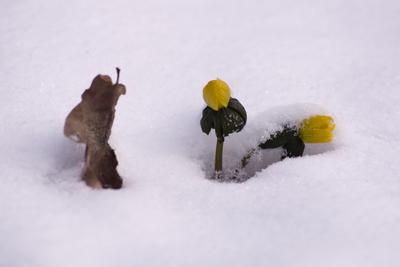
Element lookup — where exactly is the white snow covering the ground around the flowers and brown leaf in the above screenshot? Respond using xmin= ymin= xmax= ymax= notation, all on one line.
xmin=0 ymin=0 xmax=400 ymax=267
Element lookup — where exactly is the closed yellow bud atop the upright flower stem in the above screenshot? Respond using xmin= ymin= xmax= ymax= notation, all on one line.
xmin=203 ymin=79 xmax=231 ymax=111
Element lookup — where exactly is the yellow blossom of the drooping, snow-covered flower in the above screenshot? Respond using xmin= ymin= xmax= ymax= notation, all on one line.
xmin=300 ymin=115 xmax=335 ymax=143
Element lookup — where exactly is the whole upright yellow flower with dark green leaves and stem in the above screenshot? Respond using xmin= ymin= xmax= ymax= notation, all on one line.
xmin=200 ymin=79 xmax=247 ymax=178
